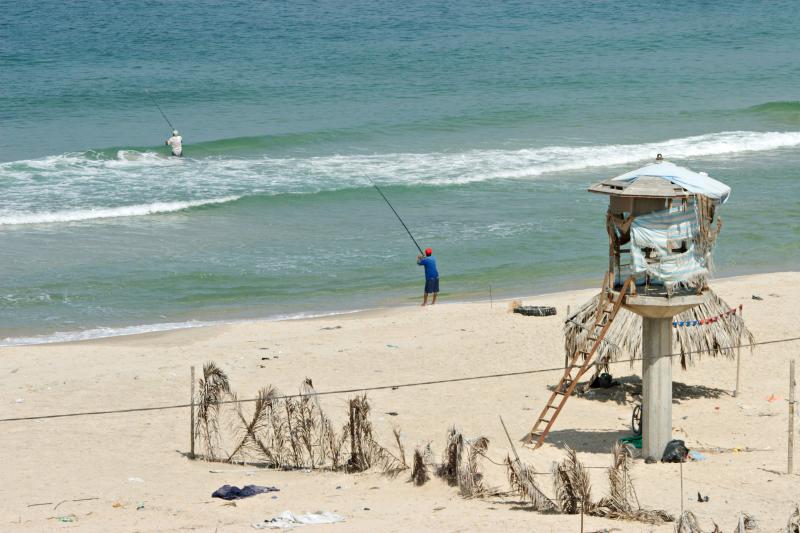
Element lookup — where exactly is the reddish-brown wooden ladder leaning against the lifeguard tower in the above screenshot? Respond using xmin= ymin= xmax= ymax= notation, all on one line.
xmin=523 ymin=274 xmax=633 ymax=449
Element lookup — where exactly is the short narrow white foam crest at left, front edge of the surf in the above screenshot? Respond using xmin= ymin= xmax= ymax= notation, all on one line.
xmin=0 ymin=196 xmax=240 ymax=226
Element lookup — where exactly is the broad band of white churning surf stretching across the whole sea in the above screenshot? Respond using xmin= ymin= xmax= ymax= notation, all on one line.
xmin=0 ymin=131 xmax=800 ymax=225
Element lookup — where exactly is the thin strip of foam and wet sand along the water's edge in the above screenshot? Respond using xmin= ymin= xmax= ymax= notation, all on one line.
xmin=0 ymin=270 xmax=797 ymax=349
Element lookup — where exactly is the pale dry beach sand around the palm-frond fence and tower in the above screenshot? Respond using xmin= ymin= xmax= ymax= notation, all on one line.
xmin=0 ymin=273 xmax=800 ymax=533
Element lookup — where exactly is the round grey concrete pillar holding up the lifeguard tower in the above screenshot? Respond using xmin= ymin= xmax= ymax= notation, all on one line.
xmin=642 ymin=317 xmax=672 ymax=460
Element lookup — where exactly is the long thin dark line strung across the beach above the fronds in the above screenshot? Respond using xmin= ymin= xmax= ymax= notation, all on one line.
xmin=0 ymin=336 xmax=800 ymax=423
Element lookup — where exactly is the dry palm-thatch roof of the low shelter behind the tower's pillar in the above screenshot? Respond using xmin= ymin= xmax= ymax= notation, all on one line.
xmin=564 ymin=289 xmax=754 ymax=369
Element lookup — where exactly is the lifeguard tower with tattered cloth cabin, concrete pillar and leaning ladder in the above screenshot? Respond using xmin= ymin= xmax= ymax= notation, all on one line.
xmin=525 ymin=154 xmax=730 ymax=459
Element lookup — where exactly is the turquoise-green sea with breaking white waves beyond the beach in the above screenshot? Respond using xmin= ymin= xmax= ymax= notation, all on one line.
xmin=0 ymin=0 xmax=800 ymax=345
